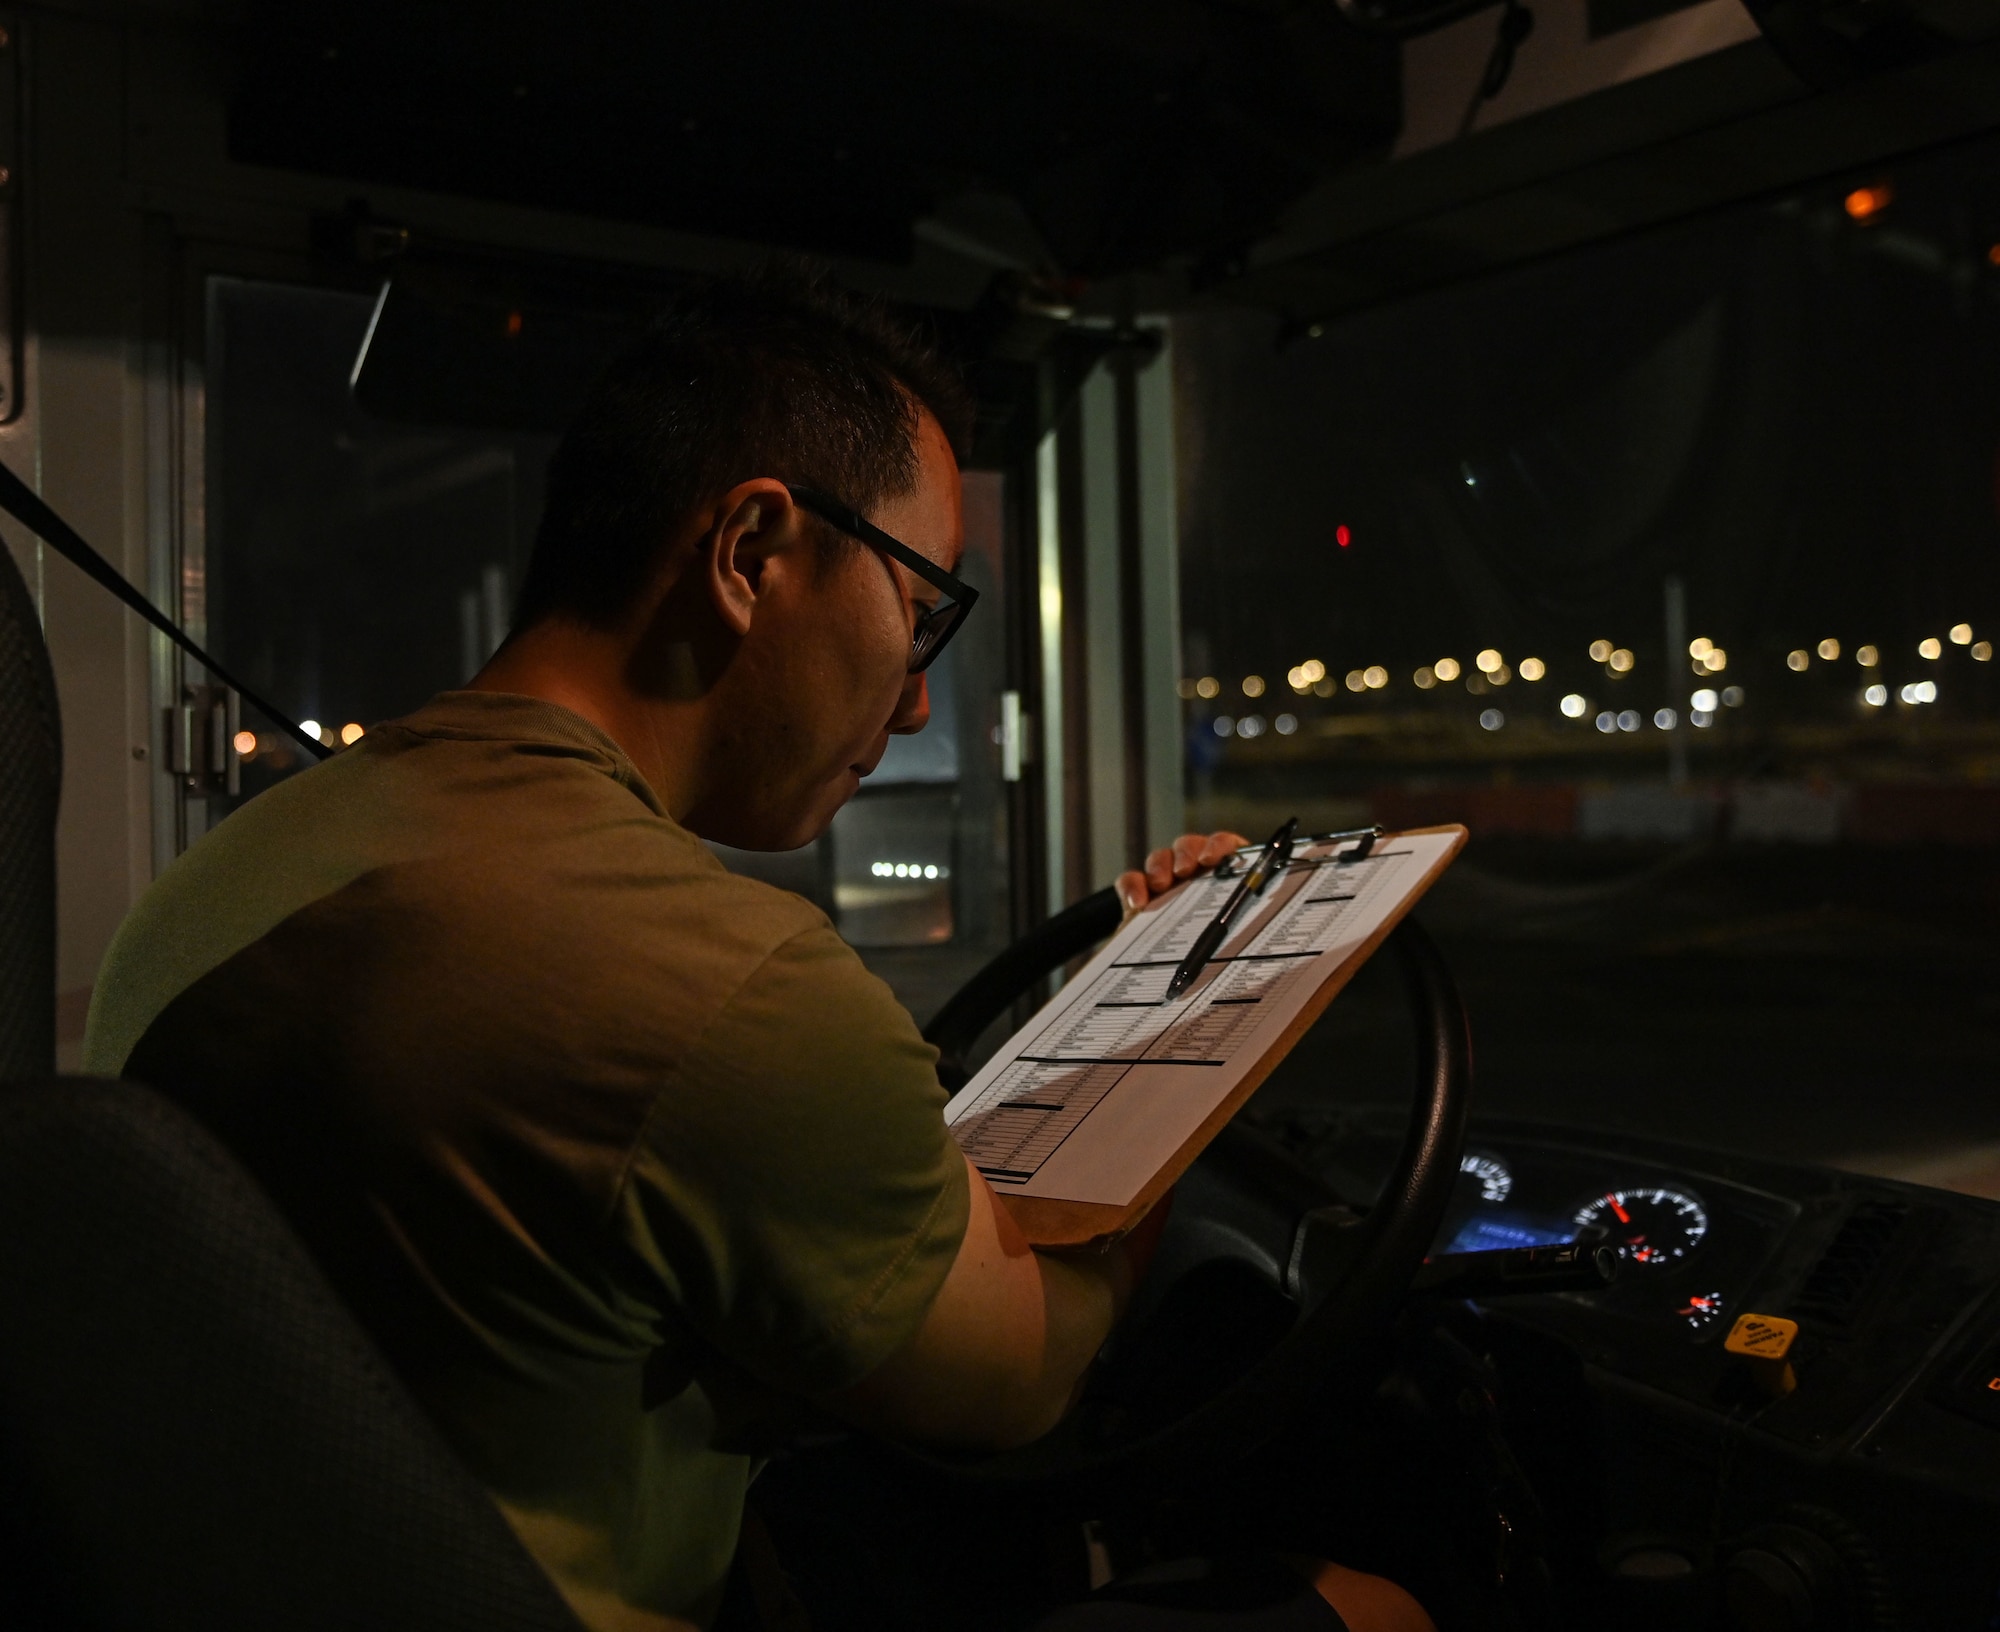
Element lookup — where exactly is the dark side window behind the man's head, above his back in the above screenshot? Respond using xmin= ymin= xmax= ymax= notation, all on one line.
xmin=205 ymin=278 xmax=554 ymax=816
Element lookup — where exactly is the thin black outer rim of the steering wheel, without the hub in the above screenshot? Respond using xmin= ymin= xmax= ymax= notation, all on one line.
xmin=918 ymin=890 xmax=1472 ymax=1500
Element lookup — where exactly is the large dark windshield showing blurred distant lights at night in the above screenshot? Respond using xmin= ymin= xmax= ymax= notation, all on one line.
xmin=1176 ymin=131 xmax=2000 ymax=1194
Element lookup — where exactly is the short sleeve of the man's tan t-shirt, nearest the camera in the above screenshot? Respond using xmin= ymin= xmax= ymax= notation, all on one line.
xmin=618 ymin=922 xmax=968 ymax=1394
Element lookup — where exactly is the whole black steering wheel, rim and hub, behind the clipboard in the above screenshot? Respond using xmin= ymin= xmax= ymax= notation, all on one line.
xmin=918 ymin=890 xmax=1472 ymax=1502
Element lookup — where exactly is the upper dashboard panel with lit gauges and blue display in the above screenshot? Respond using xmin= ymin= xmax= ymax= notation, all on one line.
xmin=1438 ymin=1124 xmax=2000 ymax=1500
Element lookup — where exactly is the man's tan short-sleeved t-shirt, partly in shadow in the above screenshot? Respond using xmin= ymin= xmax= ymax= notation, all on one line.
xmin=86 ymin=692 xmax=968 ymax=1632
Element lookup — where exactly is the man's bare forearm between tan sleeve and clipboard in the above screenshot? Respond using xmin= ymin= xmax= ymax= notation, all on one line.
xmin=826 ymin=1162 xmax=1166 ymax=1450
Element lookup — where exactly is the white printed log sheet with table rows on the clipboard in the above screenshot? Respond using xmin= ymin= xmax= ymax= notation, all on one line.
xmin=944 ymin=828 xmax=1464 ymax=1206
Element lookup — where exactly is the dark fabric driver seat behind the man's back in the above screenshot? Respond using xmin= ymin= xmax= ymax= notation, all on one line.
xmin=0 ymin=544 xmax=582 ymax=1632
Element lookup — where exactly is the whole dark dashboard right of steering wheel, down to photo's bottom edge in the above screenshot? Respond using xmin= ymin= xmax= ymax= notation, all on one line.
xmin=1284 ymin=1112 xmax=2000 ymax=1628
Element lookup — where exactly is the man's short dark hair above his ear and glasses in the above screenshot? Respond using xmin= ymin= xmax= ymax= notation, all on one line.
xmin=514 ymin=264 xmax=972 ymax=628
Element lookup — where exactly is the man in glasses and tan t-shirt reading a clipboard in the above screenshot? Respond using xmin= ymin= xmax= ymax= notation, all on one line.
xmin=86 ymin=274 xmax=1432 ymax=1632
